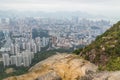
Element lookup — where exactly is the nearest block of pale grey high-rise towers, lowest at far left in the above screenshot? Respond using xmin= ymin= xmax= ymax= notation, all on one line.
xmin=2 ymin=50 xmax=34 ymax=67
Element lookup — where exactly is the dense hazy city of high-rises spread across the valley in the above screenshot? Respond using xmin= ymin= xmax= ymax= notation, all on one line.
xmin=0 ymin=17 xmax=111 ymax=67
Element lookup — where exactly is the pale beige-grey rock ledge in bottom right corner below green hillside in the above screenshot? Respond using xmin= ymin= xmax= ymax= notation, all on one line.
xmin=79 ymin=71 xmax=120 ymax=80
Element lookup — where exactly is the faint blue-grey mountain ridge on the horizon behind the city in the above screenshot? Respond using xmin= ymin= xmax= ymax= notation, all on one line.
xmin=0 ymin=10 xmax=105 ymax=19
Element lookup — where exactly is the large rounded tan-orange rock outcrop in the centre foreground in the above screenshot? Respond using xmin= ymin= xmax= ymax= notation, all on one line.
xmin=4 ymin=54 xmax=97 ymax=80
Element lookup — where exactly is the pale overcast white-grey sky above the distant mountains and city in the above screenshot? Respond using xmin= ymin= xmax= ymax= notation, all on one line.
xmin=0 ymin=0 xmax=120 ymax=16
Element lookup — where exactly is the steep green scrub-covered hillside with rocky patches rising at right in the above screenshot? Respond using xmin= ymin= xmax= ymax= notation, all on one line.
xmin=74 ymin=21 xmax=120 ymax=71
